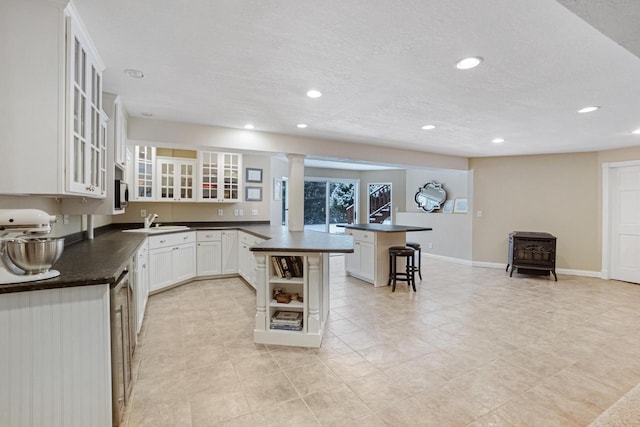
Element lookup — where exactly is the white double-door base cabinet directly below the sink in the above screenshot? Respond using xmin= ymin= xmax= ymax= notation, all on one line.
xmin=148 ymin=231 xmax=196 ymax=292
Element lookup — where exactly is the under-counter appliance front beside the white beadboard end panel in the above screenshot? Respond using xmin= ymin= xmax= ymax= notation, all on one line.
xmin=110 ymin=268 xmax=135 ymax=426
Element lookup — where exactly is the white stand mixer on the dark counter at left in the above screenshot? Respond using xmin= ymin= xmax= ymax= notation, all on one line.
xmin=0 ymin=209 xmax=64 ymax=284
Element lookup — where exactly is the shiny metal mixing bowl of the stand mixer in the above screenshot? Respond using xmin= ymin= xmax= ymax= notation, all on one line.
xmin=5 ymin=237 xmax=64 ymax=274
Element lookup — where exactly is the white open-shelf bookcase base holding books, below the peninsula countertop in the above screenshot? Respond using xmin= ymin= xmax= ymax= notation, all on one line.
xmin=254 ymin=252 xmax=329 ymax=348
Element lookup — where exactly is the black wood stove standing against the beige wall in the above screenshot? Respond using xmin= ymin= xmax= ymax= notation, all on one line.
xmin=506 ymin=231 xmax=558 ymax=282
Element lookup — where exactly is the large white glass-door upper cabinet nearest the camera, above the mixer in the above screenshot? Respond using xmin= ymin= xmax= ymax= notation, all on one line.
xmin=0 ymin=0 xmax=108 ymax=197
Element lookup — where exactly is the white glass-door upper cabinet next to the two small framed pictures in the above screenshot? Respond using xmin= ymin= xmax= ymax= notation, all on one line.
xmin=198 ymin=151 xmax=242 ymax=203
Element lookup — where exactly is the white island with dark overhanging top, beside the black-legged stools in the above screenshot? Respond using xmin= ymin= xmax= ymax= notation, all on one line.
xmin=341 ymin=224 xmax=432 ymax=287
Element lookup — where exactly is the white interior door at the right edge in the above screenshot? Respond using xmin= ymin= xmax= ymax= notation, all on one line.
xmin=611 ymin=166 xmax=640 ymax=283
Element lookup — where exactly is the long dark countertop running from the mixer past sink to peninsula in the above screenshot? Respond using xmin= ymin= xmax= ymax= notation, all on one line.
xmin=0 ymin=223 xmax=353 ymax=293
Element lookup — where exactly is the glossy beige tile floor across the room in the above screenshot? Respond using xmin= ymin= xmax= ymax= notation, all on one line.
xmin=125 ymin=256 xmax=640 ymax=427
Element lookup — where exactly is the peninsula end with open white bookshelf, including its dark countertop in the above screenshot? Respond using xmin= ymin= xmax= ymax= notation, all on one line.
xmin=251 ymin=231 xmax=353 ymax=348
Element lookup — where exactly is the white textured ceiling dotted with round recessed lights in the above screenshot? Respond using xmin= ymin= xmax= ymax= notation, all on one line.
xmin=74 ymin=0 xmax=640 ymax=157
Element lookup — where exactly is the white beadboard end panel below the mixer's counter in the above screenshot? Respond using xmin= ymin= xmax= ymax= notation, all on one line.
xmin=0 ymin=285 xmax=111 ymax=427
